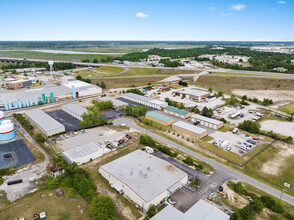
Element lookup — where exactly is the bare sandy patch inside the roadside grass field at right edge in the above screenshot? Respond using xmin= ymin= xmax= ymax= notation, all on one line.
xmin=260 ymin=143 xmax=294 ymax=176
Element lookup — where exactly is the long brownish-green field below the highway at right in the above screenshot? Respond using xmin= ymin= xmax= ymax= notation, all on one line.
xmin=196 ymin=75 xmax=294 ymax=93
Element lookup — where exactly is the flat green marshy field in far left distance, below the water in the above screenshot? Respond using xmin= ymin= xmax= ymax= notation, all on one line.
xmin=0 ymin=51 xmax=106 ymax=61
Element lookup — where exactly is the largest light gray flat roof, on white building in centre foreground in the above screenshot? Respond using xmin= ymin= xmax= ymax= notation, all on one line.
xmin=100 ymin=150 xmax=187 ymax=202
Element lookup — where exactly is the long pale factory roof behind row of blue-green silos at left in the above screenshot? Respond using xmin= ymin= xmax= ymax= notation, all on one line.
xmin=0 ymin=86 xmax=72 ymax=104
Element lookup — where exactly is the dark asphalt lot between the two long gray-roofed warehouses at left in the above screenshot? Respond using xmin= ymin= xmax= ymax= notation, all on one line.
xmin=47 ymin=110 xmax=82 ymax=131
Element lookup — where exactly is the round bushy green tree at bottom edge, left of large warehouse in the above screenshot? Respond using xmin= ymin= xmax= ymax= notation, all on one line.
xmin=89 ymin=195 xmax=115 ymax=220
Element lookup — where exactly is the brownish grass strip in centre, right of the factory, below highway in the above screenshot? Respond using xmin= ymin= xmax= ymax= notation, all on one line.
xmin=92 ymin=76 xmax=165 ymax=89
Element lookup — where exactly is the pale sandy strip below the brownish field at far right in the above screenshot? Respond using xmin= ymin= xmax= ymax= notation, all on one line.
xmin=232 ymin=89 xmax=294 ymax=102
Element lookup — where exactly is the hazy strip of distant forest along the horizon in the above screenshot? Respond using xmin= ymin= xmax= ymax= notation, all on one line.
xmin=0 ymin=41 xmax=293 ymax=49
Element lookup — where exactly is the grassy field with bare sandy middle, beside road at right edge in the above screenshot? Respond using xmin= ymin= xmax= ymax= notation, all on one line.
xmin=243 ymin=142 xmax=294 ymax=196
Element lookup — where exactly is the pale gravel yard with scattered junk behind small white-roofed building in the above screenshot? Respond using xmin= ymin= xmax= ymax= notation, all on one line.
xmin=57 ymin=127 xmax=126 ymax=151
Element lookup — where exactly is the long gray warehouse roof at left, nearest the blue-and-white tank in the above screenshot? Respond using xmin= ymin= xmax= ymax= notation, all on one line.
xmin=25 ymin=109 xmax=65 ymax=132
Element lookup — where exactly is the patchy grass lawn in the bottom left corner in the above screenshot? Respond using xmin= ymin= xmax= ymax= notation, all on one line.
xmin=0 ymin=187 xmax=91 ymax=220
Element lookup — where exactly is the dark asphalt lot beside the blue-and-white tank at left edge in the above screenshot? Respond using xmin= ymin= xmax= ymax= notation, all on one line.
xmin=0 ymin=140 xmax=35 ymax=169
